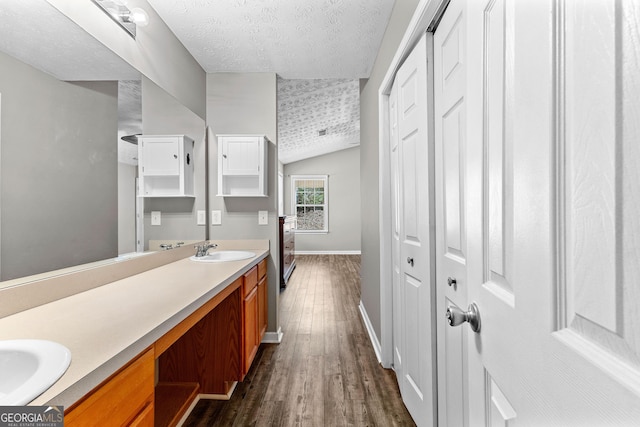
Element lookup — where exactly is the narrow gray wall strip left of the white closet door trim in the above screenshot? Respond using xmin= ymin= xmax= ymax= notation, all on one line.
xmin=360 ymin=0 xmax=418 ymax=340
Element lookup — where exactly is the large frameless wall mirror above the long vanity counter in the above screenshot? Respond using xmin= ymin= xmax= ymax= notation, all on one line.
xmin=0 ymin=1 xmax=206 ymax=287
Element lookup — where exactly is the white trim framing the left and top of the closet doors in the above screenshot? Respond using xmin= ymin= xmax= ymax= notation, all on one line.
xmin=378 ymin=0 xmax=449 ymax=368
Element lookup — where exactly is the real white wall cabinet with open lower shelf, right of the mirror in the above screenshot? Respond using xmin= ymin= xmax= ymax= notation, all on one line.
xmin=218 ymin=135 xmax=269 ymax=197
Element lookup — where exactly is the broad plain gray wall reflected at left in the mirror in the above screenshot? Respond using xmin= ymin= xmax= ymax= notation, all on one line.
xmin=0 ymin=53 xmax=118 ymax=280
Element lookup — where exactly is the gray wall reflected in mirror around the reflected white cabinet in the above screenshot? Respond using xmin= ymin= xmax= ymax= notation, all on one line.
xmin=142 ymin=76 xmax=206 ymax=250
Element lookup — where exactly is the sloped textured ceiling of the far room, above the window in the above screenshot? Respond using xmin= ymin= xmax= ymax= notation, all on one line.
xmin=278 ymin=79 xmax=360 ymax=163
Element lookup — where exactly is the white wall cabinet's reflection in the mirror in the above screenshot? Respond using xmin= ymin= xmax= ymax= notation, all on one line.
xmin=138 ymin=135 xmax=194 ymax=197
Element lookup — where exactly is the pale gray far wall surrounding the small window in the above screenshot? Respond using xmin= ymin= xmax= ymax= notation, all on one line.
xmin=284 ymin=147 xmax=360 ymax=253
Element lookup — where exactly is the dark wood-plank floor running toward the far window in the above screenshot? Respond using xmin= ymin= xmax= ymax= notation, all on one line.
xmin=184 ymin=255 xmax=415 ymax=427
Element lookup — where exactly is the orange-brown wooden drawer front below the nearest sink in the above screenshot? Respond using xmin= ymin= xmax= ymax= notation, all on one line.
xmin=64 ymin=349 xmax=154 ymax=426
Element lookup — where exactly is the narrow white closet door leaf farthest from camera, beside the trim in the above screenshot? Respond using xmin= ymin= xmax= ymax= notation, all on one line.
xmin=392 ymin=32 xmax=436 ymax=425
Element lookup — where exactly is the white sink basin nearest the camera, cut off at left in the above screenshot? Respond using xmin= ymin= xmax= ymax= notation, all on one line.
xmin=0 ymin=340 xmax=71 ymax=406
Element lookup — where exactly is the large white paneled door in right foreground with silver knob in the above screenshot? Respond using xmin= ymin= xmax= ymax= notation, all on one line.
xmin=460 ymin=0 xmax=640 ymax=426
